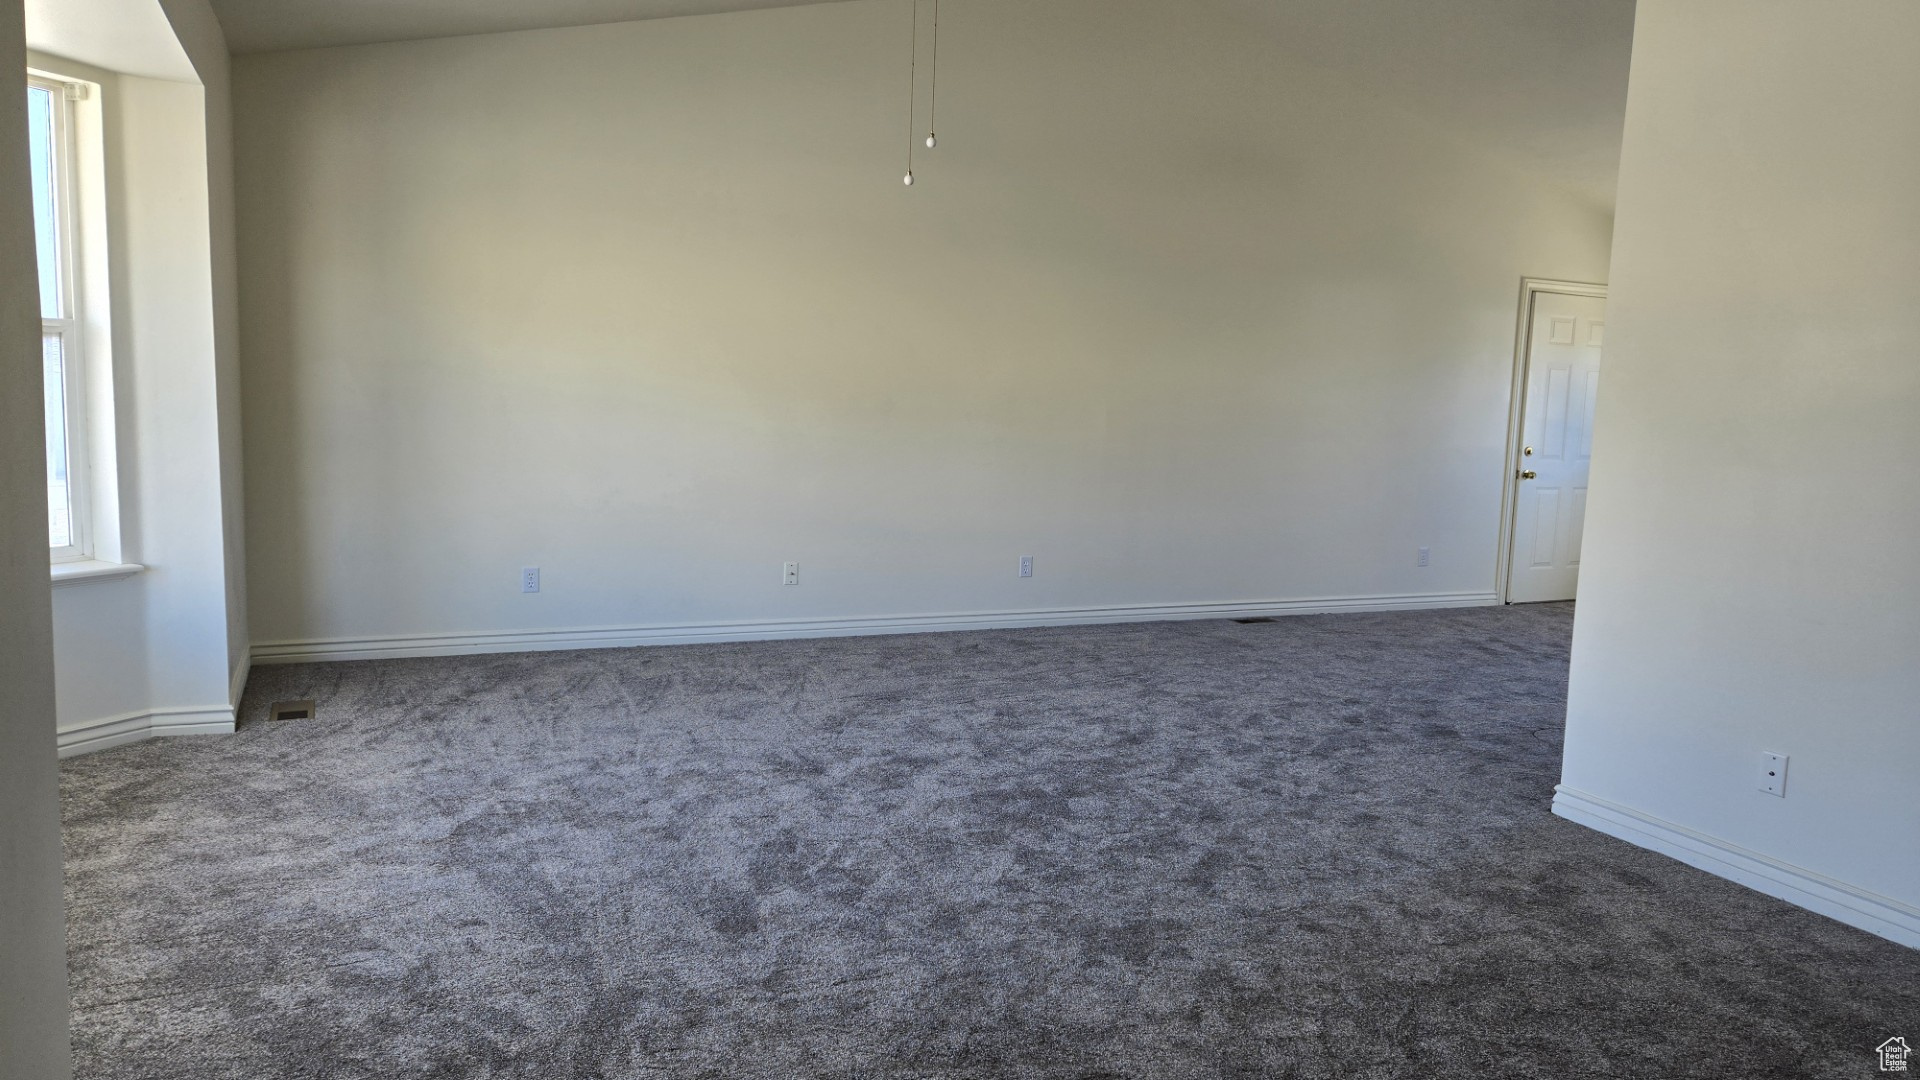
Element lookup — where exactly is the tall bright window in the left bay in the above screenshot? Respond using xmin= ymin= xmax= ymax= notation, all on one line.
xmin=27 ymin=75 xmax=94 ymax=563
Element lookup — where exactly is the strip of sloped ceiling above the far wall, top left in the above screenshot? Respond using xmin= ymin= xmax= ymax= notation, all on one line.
xmin=204 ymin=0 xmax=856 ymax=52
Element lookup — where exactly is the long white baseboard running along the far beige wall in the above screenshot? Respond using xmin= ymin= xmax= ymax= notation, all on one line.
xmin=253 ymin=592 xmax=1496 ymax=663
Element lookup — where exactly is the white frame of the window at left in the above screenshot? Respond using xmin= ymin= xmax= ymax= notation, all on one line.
xmin=27 ymin=73 xmax=94 ymax=563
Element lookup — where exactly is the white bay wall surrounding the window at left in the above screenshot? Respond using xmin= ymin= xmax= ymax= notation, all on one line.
xmin=29 ymin=0 xmax=246 ymax=751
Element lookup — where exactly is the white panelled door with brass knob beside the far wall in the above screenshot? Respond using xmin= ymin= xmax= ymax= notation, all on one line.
xmin=1507 ymin=292 xmax=1607 ymax=603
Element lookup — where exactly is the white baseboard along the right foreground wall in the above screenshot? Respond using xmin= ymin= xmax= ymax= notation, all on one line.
xmin=1553 ymin=784 xmax=1920 ymax=949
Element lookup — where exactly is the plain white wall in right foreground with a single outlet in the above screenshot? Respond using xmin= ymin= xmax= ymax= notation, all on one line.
xmin=1557 ymin=0 xmax=1920 ymax=945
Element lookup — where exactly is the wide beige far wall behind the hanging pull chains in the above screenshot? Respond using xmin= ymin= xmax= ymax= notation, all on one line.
xmin=234 ymin=0 xmax=1630 ymax=642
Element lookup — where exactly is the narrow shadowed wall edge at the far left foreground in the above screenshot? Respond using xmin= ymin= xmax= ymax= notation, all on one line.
xmin=0 ymin=0 xmax=71 ymax=1080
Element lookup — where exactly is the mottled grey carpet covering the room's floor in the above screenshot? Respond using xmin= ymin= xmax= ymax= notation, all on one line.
xmin=63 ymin=605 xmax=1920 ymax=1080
